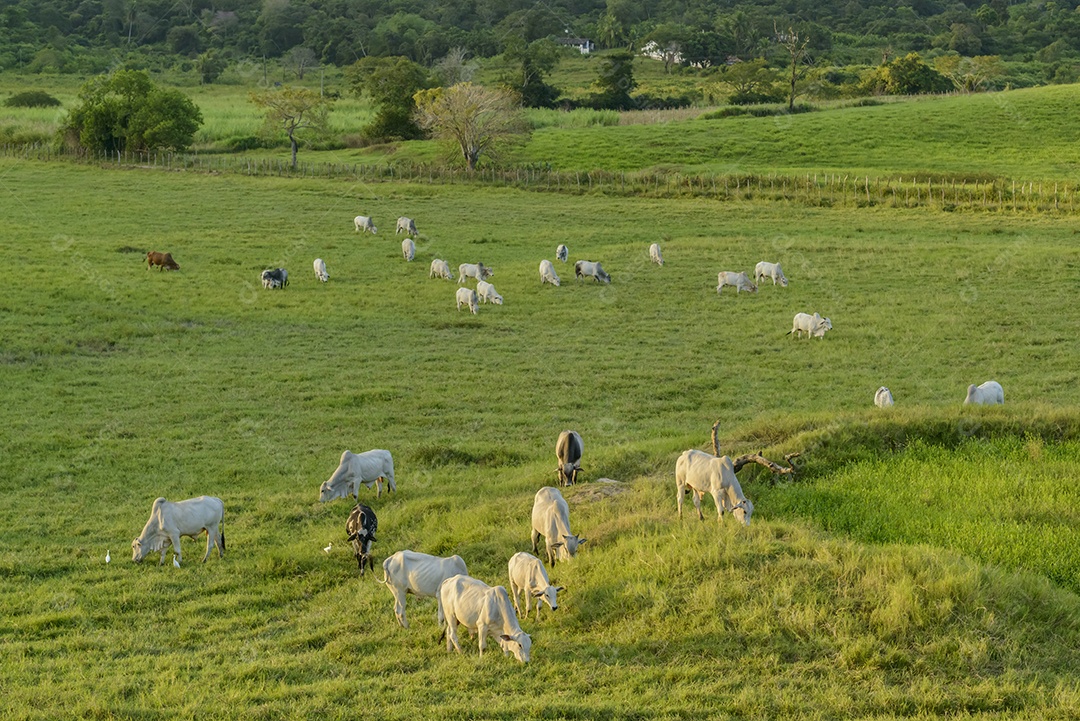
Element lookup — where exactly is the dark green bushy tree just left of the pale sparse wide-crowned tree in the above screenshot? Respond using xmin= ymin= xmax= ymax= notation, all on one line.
xmin=346 ymin=57 xmax=428 ymax=140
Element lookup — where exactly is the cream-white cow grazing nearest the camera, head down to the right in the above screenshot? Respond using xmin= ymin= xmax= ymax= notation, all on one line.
xmin=438 ymin=574 xmax=532 ymax=664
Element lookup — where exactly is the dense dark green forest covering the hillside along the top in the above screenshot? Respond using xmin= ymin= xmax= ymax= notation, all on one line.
xmin=6 ymin=0 xmax=1080 ymax=82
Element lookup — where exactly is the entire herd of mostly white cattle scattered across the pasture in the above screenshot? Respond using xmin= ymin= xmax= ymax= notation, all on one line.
xmin=132 ymin=211 xmax=1004 ymax=663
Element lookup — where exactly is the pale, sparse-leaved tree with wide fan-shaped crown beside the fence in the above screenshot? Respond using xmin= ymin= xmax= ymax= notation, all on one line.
xmin=416 ymin=83 xmax=528 ymax=171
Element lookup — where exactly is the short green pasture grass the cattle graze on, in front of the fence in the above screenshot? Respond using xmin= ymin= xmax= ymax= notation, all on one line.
xmin=0 ymin=161 xmax=1080 ymax=719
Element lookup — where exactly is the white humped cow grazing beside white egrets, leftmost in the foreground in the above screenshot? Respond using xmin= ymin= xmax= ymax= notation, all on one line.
xmin=132 ymin=495 xmax=225 ymax=566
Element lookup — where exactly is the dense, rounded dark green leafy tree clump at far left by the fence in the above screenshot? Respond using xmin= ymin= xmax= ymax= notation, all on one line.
xmin=60 ymin=70 xmax=203 ymax=153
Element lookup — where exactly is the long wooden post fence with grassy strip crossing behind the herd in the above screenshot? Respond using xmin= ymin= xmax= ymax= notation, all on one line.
xmin=6 ymin=145 xmax=1078 ymax=214
